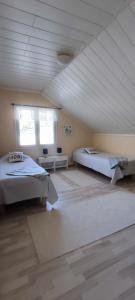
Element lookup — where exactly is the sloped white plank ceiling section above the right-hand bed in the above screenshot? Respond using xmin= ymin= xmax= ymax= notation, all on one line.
xmin=44 ymin=0 xmax=135 ymax=134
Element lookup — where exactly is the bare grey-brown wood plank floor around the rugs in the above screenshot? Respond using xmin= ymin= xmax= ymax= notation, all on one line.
xmin=0 ymin=166 xmax=135 ymax=300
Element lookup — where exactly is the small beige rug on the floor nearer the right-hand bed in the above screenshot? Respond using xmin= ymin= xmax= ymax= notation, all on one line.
xmin=62 ymin=170 xmax=100 ymax=187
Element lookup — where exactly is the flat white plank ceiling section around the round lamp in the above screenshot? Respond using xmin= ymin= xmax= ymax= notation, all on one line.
xmin=0 ymin=0 xmax=134 ymax=91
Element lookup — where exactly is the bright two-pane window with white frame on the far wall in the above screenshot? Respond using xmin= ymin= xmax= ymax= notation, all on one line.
xmin=16 ymin=106 xmax=55 ymax=146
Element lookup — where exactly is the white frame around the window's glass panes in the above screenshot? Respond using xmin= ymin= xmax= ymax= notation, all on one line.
xmin=15 ymin=105 xmax=57 ymax=148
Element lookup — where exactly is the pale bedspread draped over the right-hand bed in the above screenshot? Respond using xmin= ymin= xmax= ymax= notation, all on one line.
xmin=73 ymin=149 xmax=135 ymax=183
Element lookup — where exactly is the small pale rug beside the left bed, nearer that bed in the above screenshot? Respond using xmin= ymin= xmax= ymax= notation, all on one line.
xmin=51 ymin=174 xmax=72 ymax=193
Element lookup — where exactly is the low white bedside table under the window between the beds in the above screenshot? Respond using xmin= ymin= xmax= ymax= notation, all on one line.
xmin=38 ymin=155 xmax=68 ymax=172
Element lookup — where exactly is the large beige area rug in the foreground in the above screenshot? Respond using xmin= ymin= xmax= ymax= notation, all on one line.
xmin=28 ymin=191 xmax=135 ymax=262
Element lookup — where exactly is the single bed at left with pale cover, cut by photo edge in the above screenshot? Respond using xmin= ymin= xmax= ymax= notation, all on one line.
xmin=0 ymin=155 xmax=58 ymax=204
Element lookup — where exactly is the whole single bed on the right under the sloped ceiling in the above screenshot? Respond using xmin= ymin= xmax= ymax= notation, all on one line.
xmin=73 ymin=148 xmax=135 ymax=184
